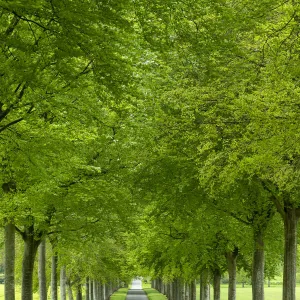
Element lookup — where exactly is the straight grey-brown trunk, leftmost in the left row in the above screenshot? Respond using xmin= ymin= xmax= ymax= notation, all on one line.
xmin=4 ymin=223 xmax=15 ymax=300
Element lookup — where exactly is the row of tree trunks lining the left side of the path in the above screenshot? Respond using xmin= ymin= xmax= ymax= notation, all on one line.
xmin=5 ymin=231 xmax=120 ymax=300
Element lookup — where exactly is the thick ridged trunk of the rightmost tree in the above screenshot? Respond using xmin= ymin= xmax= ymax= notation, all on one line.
xmin=283 ymin=207 xmax=298 ymax=300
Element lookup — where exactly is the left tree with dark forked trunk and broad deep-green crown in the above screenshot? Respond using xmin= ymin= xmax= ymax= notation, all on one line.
xmin=0 ymin=1 xmax=143 ymax=299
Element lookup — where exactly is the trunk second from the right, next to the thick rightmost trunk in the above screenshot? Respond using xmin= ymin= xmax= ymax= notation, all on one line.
xmin=252 ymin=230 xmax=265 ymax=300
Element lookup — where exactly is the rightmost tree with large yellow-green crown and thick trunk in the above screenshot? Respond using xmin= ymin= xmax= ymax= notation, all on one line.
xmin=133 ymin=1 xmax=298 ymax=299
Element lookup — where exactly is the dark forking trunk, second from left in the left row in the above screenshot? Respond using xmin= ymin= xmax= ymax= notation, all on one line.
xmin=22 ymin=225 xmax=41 ymax=300
